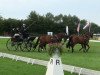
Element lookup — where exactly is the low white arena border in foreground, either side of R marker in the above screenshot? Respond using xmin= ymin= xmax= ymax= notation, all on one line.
xmin=0 ymin=52 xmax=100 ymax=75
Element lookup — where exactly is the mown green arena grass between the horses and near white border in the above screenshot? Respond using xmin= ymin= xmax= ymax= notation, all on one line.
xmin=0 ymin=39 xmax=100 ymax=71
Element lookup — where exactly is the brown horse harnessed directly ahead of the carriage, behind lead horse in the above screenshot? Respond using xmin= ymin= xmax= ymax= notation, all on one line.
xmin=34 ymin=33 xmax=68 ymax=50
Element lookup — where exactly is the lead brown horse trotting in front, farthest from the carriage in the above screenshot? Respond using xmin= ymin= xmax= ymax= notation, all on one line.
xmin=66 ymin=33 xmax=93 ymax=52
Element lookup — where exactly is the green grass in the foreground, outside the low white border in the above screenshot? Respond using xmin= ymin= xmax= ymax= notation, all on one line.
xmin=0 ymin=58 xmax=76 ymax=75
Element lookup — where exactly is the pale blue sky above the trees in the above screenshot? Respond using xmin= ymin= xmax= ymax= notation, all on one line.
xmin=0 ymin=0 xmax=100 ymax=26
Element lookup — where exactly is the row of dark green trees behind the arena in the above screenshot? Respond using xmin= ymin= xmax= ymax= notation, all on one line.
xmin=0 ymin=11 xmax=100 ymax=35
